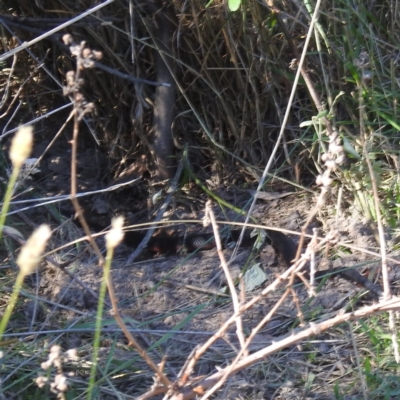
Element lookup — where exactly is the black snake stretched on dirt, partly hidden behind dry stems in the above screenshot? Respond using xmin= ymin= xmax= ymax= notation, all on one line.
xmin=125 ymin=229 xmax=383 ymax=298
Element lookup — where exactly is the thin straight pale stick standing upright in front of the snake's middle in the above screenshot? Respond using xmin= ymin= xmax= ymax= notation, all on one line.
xmin=204 ymin=200 xmax=246 ymax=349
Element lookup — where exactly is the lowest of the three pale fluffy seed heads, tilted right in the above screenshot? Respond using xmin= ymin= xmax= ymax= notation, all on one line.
xmin=17 ymin=225 xmax=51 ymax=276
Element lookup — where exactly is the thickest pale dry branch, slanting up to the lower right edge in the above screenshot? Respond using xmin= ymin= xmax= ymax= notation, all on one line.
xmin=171 ymin=297 xmax=400 ymax=400
